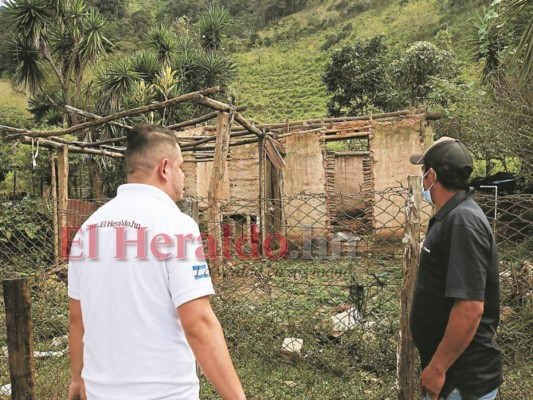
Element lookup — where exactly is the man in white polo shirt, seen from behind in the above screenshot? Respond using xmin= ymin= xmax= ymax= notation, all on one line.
xmin=68 ymin=125 xmax=245 ymax=400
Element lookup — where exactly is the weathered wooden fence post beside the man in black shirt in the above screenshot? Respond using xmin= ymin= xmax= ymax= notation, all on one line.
xmin=396 ymin=176 xmax=421 ymax=400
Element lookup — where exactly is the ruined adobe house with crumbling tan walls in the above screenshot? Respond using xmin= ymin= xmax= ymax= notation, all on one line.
xmin=184 ymin=111 xmax=433 ymax=241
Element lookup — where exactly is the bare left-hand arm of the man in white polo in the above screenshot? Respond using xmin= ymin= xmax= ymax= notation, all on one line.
xmin=68 ymin=299 xmax=86 ymax=400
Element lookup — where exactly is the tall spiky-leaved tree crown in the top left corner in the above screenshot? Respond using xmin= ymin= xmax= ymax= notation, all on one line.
xmin=6 ymin=0 xmax=107 ymax=123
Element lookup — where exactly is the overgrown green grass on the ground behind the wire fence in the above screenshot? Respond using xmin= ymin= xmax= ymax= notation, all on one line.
xmin=0 ymin=243 xmax=533 ymax=400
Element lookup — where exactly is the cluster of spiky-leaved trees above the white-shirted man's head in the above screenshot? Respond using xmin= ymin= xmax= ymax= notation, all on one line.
xmin=95 ymin=6 xmax=236 ymax=119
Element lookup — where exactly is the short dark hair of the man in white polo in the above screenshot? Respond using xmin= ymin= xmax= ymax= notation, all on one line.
xmin=124 ymin=125 xmax=178 ymax=175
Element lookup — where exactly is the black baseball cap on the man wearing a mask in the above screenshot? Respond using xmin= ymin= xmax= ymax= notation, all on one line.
xmin=409 ymin=136 xmax=474 ymax=172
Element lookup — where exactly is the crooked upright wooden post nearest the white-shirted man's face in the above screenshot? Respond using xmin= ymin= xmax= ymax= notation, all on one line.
xmin=207 ymin=112 xmax=231 ymax=279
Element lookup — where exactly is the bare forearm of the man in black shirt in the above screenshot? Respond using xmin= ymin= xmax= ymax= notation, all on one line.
xmin=420 ymin=300 xmax=483 ymax=400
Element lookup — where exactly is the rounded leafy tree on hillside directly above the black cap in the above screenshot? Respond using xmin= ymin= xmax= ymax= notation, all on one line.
xmin=392 ymin=42 xmax=456 ymax=106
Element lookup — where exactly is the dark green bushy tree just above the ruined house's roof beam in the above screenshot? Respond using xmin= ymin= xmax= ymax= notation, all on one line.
xmin=322 ymin=36 xmax=398 ymax=116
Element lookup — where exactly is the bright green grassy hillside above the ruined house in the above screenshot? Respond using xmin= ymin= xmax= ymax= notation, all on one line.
xmin=233 ymin=0 xmax=479 ymax=122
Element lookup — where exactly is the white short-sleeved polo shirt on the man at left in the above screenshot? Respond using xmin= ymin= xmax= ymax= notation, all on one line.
xmin=68 ymin=184 xmax=214 ymax=400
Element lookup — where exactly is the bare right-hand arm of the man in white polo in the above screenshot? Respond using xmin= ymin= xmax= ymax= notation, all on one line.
xmin=178 ymin=297 xmax=246 ymax=400
